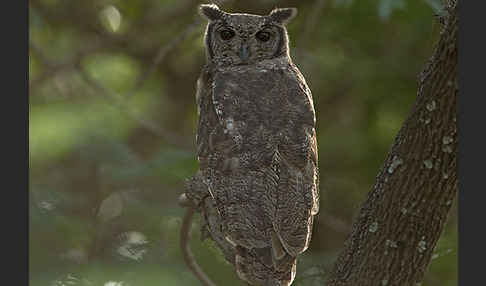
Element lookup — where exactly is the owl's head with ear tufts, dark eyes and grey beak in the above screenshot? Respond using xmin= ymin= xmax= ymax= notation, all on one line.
xmin=199 ymin=4 xmax=297 ymax=66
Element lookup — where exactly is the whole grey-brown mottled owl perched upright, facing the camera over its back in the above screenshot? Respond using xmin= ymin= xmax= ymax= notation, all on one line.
xmin=188 ymin=4 xmax=319 ymax=286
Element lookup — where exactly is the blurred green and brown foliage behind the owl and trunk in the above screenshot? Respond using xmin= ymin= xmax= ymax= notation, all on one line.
xmin=29 ymin=0 xmax=457 ymax=286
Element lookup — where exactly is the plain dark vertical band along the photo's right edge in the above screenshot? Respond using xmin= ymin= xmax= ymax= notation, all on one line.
xmin=457 ymin=0 xmax=474 ymax=285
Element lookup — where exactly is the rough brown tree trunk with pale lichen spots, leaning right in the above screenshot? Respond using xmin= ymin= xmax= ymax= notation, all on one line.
xmin=327 ymin=1 xmax=458 ymax=286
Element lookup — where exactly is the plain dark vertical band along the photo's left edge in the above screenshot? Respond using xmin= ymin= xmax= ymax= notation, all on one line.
xmin=12 ymin=1 xmax=29 ymax=285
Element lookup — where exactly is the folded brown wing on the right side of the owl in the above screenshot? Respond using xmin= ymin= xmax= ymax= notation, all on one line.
xmin=273 ymin=66 xmax=319 ymax=256
